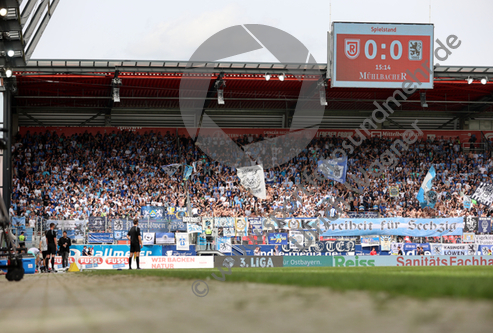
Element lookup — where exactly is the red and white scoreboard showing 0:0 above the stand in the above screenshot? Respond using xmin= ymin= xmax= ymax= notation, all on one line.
xmin=327 ymin=22 xmax=433 ymax=89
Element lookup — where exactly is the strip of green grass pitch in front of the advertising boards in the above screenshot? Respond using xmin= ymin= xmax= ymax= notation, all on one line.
xmin=83 ymin=266 xmax=493 ymax=300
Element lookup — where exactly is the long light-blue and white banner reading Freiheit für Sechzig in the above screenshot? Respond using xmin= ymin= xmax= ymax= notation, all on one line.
xmin=320 ymin=217 xmax=464 ymax=237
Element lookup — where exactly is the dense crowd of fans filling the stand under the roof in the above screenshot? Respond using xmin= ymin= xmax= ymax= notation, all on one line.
xmin=10 ymin=131 xmax=493 ymax=219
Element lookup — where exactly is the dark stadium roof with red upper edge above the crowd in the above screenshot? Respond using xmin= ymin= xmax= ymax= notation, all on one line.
xmin=9 ymin=60 xmax=493 ymax=129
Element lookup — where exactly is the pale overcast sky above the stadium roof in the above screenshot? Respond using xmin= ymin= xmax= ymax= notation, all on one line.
xmin=31 ymin=0 xmax=493 ymax=66
